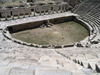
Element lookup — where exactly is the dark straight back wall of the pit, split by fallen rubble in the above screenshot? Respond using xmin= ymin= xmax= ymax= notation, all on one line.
xmin=8 ymin=16 xmax=73 ymax=33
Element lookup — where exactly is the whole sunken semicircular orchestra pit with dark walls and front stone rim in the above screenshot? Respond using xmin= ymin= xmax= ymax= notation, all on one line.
xmin=4 ymin=16 xmax=90 ymax=48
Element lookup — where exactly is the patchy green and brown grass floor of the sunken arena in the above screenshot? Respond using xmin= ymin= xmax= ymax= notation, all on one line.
xmin=11 ymin=21 xmax=89 ymax=45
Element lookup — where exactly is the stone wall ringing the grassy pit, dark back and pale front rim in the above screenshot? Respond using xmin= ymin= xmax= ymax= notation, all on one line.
xmin=3 ymin=16 xmax=91 ymax=48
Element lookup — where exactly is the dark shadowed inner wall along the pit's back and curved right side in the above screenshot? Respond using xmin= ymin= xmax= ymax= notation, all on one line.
xmin=8 ymin=16 xmax=91 ymax=33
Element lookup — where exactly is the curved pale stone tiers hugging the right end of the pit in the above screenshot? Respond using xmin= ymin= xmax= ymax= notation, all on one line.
xmin=77 ymin=17 xmax=99 ymax=47
